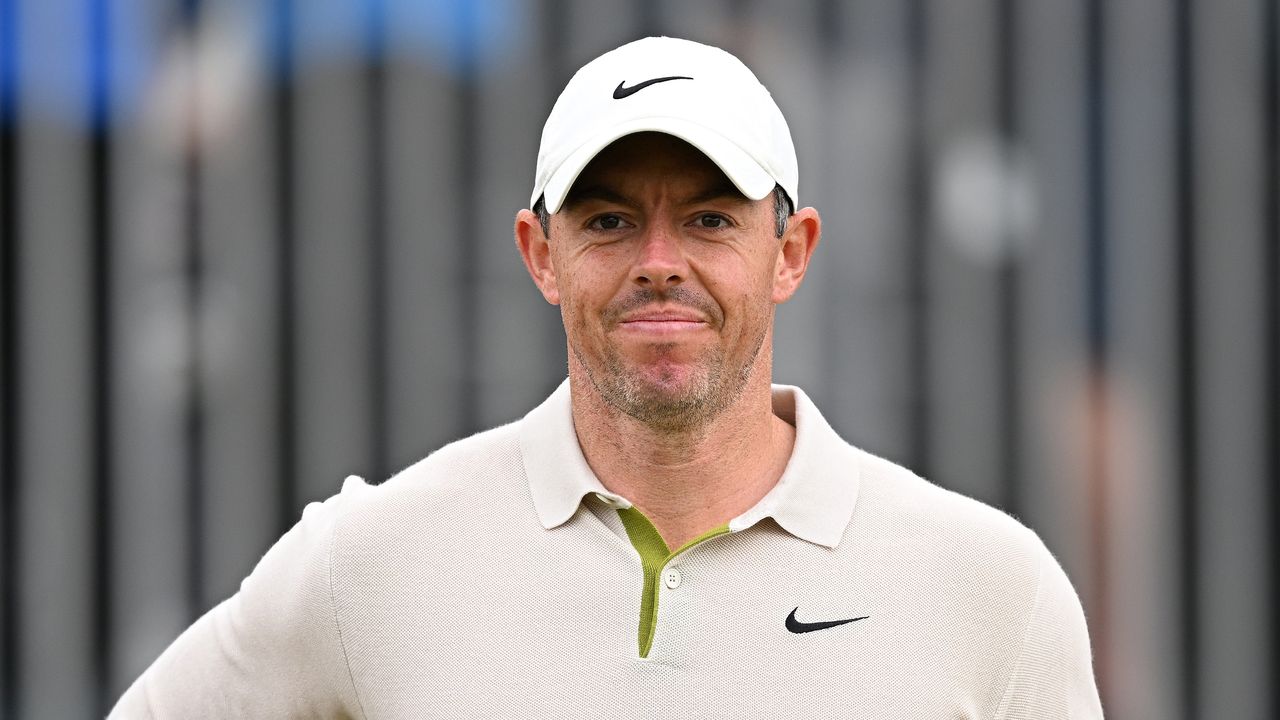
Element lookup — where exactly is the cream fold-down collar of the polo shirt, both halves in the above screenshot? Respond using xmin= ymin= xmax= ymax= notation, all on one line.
xmin=520 ymin=379 xmax=860 ymax=547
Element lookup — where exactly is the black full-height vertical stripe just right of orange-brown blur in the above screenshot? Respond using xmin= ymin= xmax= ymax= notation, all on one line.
xmin=1172 ymin=0 xmax=1201 ymax=719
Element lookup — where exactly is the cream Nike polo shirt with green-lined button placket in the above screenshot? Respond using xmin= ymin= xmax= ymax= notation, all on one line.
xmin=111 ymin=383 xmax=1102 ymax=720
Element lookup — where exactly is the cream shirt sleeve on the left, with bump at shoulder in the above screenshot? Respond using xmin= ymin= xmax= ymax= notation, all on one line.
xmin=109 ymin=478 xmax=365 ymax=720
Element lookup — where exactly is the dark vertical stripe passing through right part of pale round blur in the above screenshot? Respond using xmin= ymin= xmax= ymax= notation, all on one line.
xmin=996 ymin=0 xmax=1023 ymax=515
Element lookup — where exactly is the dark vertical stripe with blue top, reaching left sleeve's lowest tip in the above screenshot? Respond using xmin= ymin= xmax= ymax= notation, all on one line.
xmin=88 ymin=0 xmax=114 ymax=715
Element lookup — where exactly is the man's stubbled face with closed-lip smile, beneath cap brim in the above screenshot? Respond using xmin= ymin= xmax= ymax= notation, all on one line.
xmin=535 ymin=133 xmax=790 ymax=429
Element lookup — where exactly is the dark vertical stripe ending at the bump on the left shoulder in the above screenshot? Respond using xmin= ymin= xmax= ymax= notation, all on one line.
xmin=365 ymin=0 xmax=390 ymax=482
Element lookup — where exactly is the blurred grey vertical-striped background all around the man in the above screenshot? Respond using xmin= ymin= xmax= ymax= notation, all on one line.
xmin=0 ymin=0 xmax=1280 ymax=720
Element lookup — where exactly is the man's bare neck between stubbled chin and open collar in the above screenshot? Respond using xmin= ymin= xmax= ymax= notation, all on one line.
xmin=570 ymin=368 xmax=795 ymax=550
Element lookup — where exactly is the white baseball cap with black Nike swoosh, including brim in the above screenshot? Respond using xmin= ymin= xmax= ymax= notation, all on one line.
xmin=529 ymin=37 xmax=800 ymax=213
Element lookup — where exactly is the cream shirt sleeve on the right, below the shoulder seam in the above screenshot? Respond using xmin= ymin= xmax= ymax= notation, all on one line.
xmin=995 ymin=541 xmax=1102 ymax=720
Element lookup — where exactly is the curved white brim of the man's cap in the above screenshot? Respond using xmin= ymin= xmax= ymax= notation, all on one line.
xmin=530 ymin=118 xmax=777 ymax=213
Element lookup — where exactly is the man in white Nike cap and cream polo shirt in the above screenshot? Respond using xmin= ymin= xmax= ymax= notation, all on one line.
xmin=114 ymin=38 xmax=1101 ymax=719
